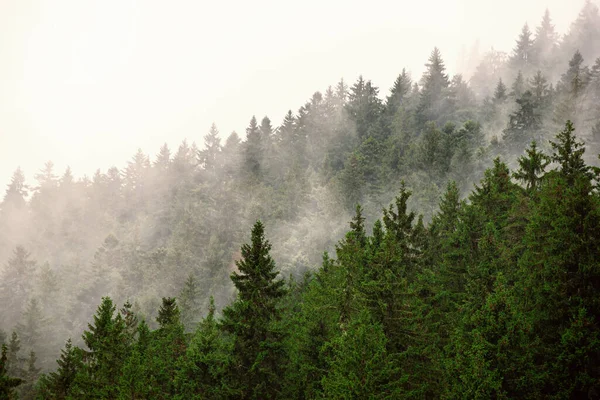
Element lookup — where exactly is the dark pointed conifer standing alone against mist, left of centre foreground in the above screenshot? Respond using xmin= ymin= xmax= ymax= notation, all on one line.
xmin=221 ymin=221 xmax=285 ymax=399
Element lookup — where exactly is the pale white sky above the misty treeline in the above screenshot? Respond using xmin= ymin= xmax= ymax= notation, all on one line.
xmin=0 ymin=0 xmax=584 ymax=188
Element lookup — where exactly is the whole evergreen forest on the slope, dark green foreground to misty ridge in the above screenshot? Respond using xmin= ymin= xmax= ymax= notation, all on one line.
xmin=0 ymin=1 xmax=600 ymax=399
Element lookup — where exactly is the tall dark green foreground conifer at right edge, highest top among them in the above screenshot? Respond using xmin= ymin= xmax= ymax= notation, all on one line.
xmin=517 ymin=121 xmax=600 ymax=398
